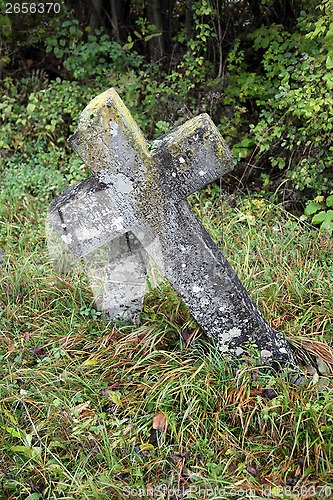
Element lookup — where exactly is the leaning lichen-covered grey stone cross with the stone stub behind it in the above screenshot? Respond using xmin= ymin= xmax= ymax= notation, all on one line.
xmin=48 ymin=89 xmax=294 ymax=365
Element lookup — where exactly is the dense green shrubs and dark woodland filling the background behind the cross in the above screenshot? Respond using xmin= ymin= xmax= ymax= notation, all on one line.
xmin=0 ymin=0 xmax=333 ymax=223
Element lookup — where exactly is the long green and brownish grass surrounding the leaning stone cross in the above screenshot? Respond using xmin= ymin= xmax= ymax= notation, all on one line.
xmin=0 ymin=187 xmax=333 ymax=500
